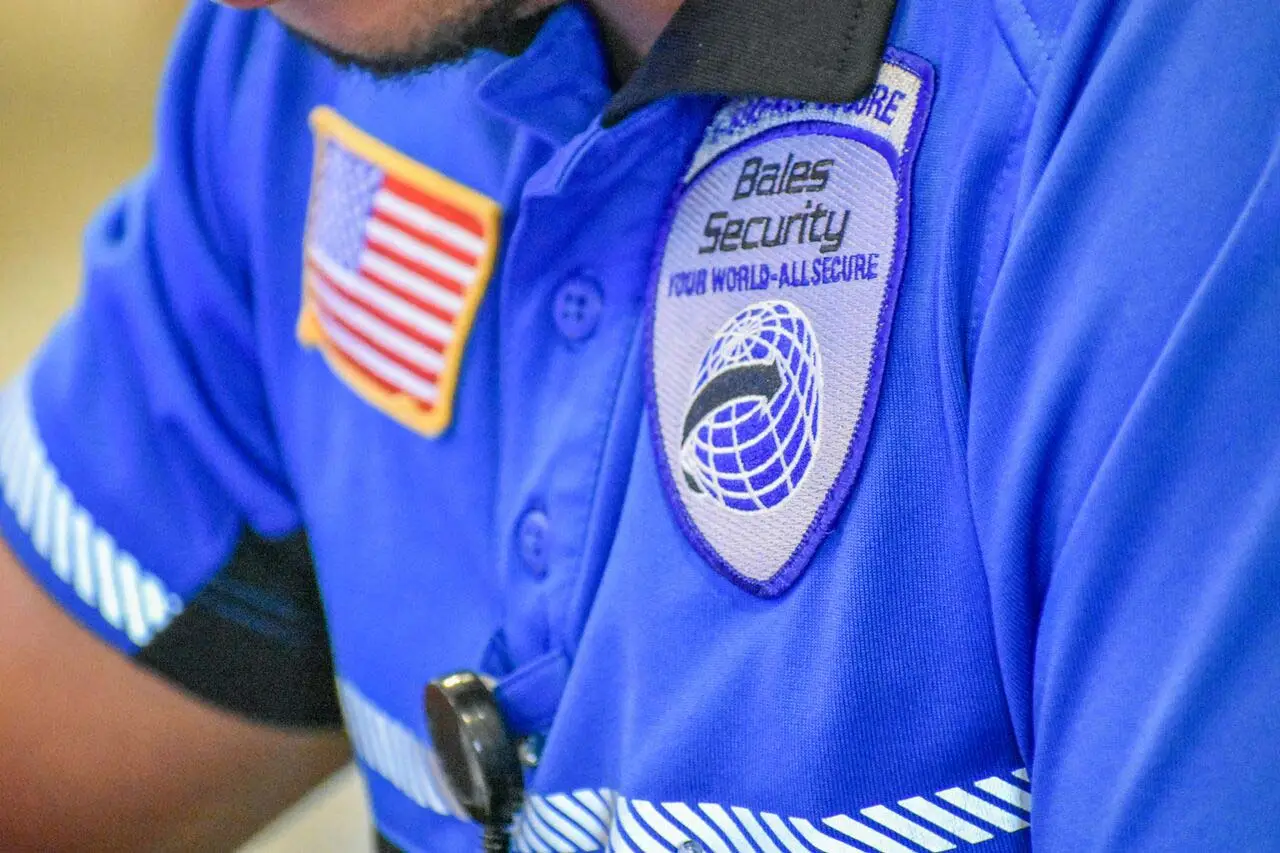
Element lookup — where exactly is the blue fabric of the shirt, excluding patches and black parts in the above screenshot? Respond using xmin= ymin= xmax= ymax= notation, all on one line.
xmin=0 ymin=0 xmax=1280 ymax=853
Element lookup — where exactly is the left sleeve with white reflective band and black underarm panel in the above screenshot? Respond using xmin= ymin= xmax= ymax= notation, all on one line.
xmin=0 ymin=3 xmax=337 ymax=725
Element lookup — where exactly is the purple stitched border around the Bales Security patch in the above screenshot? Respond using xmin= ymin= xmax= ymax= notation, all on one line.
xmin=645 ymin=47 xmax=934 ymax=598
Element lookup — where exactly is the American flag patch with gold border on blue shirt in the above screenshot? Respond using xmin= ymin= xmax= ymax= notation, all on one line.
xmin=298 ymin=108 xmax=500 ymax=437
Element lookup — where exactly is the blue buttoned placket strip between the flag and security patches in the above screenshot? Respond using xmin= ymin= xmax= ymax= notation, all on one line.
xmin=486 ymin=101 xmax=704 ymax=747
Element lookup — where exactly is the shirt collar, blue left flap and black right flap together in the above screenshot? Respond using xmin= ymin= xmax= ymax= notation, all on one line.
xmin=479 ymin=0 xmax=897 ymax=143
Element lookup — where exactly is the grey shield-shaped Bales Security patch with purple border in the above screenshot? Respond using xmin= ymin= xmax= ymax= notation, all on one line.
xmin=648 ymin=49 xmax=933 ymax=596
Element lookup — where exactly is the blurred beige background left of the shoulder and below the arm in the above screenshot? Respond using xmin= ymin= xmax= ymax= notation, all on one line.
xmin=0 ymin=0 xmax=371 ymax=853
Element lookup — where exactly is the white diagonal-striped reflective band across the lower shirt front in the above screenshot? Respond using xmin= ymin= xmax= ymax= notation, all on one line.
xmin=338 ymin=679 xmax=1032 ymax=853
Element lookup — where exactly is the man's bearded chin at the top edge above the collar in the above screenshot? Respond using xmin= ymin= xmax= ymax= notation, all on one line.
xmin=271 ymin=0 xmax=553 ymax=78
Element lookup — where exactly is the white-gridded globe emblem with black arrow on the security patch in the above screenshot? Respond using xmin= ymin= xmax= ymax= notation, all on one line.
xmin=680 ymin=300 xmax=822 ymax=512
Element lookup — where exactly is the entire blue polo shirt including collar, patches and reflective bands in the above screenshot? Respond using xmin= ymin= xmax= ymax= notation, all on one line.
xmin=0 ymin=0 xmax=1280 ymax=853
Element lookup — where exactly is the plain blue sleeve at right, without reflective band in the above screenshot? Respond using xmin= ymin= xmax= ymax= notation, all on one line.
xmin=969 ymin=0 xmax=1280 ymax=852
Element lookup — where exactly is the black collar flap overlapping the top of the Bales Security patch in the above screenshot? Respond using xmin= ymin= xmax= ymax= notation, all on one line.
xmin=604 ymin=0 xmax=897 ymax=124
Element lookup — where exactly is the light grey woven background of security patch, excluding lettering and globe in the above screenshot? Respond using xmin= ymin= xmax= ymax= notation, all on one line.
xmin=653 ymin=65 xmax=920 ymax=581
